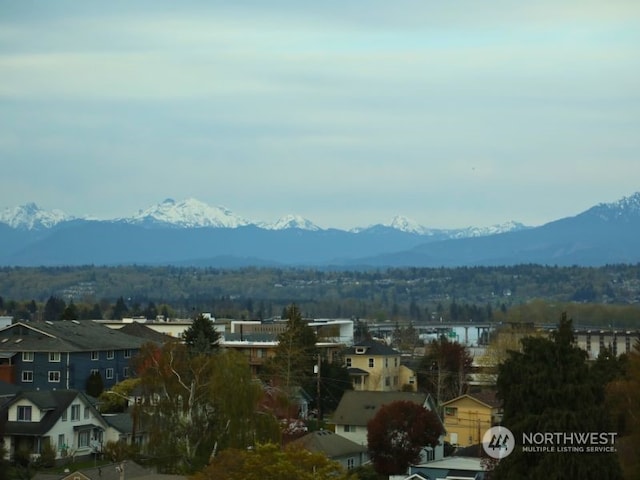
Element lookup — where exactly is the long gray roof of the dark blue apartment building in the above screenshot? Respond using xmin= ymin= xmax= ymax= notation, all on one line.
xmin=0 ymin=320 xmax=147 ymax=352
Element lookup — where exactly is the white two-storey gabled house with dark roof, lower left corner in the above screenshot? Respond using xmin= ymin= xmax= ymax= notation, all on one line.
xmin=0 ymin=390 xmax=108 ymax=459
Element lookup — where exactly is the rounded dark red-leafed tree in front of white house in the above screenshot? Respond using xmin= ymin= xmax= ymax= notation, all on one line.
xmin=367 ymin=401 xmax=444 ymax=475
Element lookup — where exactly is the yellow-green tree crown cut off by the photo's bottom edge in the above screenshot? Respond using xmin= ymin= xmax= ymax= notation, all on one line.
xmin=191 ymin=444 xmax=356 ymax=480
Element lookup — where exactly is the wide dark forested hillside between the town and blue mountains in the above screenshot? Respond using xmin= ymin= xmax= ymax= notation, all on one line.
xmin=0 ymin=265 xmax=640 ymax=324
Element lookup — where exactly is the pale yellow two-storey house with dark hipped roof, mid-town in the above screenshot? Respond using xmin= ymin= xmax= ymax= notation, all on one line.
xmin=344 ymin=340 xmax=418 ymax=392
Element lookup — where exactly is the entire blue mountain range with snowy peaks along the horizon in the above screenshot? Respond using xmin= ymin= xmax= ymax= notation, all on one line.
xmin=0 ymin=192 xmax=640 ymax=269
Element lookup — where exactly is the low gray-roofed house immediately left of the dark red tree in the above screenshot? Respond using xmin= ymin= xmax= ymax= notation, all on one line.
xmin=291 ymin=430 xmax=369 ymax=470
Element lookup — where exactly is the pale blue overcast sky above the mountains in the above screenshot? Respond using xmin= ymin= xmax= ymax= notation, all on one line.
xmin=0 ymin=0 xmax=640 ymax=228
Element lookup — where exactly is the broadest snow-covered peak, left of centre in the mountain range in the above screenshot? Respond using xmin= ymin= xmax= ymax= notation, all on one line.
xmin=123 ymin=198 xmax=250 ymax=228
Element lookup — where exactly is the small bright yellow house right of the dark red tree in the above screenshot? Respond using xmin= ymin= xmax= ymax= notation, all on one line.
xmin=442 ymin=392 xmax=502 ymax=447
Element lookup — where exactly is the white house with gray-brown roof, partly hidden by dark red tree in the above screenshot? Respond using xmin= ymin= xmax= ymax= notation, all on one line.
xmin=332 ymin=390 xmax=444 ymax=461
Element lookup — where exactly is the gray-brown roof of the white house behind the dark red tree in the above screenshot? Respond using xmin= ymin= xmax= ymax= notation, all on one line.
xmin=333 ymin=390 xmax=428 ymax=426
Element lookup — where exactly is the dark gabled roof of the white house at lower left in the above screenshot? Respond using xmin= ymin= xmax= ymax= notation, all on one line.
xmin=1 ymin=390 xmax=106 ymax=436
